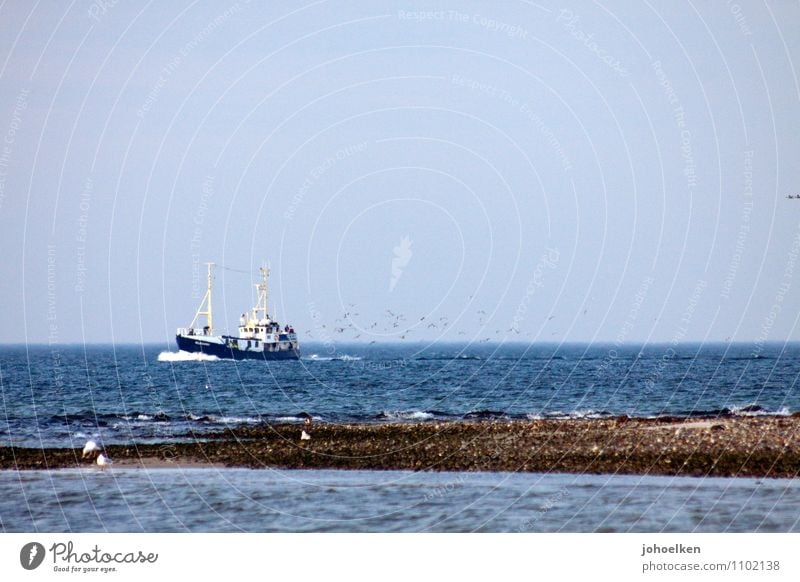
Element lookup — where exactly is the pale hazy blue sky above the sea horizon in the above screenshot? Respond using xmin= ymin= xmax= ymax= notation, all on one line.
xmin=0 ymin=0 xmax=800 ymax=342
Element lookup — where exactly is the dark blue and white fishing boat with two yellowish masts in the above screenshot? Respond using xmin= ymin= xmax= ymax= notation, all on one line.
xmin=175 ymin=263 xmax=300 ymax=360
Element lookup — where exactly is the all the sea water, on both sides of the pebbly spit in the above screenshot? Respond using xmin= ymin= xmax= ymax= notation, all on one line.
xmin=0 ymin=343 xmax=800 ymax=532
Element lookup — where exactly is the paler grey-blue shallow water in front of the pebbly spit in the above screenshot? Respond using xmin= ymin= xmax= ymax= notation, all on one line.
xmin=0 ymin=468 xmax=800 ymax=532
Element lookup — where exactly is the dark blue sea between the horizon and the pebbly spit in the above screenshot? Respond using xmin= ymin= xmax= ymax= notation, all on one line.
xmin=0 ymin=344 xmax=800 ymax=446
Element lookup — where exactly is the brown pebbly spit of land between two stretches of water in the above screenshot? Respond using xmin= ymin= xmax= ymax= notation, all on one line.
xmin=0 ymin=416 xmax=800 ymax=478
